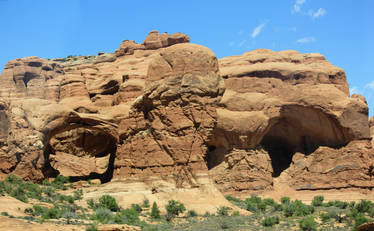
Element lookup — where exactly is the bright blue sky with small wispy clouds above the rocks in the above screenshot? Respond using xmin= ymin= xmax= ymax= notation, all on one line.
xmin=0 ymin=0 xmax=374 ymax=116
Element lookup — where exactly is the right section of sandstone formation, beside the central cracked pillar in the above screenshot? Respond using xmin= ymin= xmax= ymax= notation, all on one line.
xmin=208 ymin=49 xmax=373 ymax=192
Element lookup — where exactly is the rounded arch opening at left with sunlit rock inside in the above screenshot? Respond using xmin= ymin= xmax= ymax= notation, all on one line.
xmin=45 ymin=126 xmax=117 ymax=182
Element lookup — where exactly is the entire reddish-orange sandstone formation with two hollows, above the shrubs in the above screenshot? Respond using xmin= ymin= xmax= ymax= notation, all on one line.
xmin=0 ymin=32 xmax=374 ymax=194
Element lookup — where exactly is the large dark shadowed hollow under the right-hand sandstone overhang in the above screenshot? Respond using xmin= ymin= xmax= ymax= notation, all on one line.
xmin=261 ymin=106 xmax=350 ymax=177
